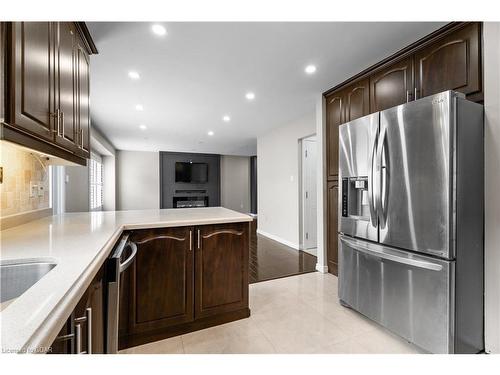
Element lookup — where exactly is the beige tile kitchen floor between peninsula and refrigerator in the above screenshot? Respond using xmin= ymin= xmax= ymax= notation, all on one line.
xmin=121 ymin=272 xmax=421 ymax=354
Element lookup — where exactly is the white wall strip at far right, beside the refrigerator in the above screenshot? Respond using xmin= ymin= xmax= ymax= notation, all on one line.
xmin=484 ymin=22 xmax=500 ymax=353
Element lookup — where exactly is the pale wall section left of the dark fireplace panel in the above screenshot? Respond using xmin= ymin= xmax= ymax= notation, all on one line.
xmin=116 ymin=151 xmax=160 ymax=210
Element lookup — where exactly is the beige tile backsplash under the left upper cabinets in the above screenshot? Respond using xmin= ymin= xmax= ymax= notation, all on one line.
xmin=0 ymin=142 xmax=50 ymax=218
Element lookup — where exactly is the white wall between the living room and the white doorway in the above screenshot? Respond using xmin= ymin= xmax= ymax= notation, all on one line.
xmin=257 ymin=111 xmax=319 ymax=249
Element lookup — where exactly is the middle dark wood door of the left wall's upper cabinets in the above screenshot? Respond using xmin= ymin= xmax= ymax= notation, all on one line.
xmin=56 ymin=22 xmax=78 ymax=152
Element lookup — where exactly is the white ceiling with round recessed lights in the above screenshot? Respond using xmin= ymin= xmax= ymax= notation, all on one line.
xmin=88 ymin=22 xmax=444 ymax=155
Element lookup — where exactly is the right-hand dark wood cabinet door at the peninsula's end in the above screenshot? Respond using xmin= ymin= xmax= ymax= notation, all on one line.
xmin=195 ymin=223 xmax=249 ymax=319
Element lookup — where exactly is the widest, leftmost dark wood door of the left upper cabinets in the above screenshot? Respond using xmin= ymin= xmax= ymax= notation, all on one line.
xmin=7 ymin=22 xmax=56 ymax=141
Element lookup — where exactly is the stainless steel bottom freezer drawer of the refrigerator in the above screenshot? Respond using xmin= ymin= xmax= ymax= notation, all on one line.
xmin=339 ymin=235 xmax=455 ymax=353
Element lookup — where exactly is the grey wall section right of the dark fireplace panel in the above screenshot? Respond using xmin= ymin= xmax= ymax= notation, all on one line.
xmin=220 ymin=155 xmax=250 ymax=213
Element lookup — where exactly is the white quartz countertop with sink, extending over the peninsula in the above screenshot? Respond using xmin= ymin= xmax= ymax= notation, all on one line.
xmin=0 ymin=207 xmax=252 ymax=353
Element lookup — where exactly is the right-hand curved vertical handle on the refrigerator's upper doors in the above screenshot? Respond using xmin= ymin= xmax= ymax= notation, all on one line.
xmin=375 ymin=127 xmax=389 ymax=229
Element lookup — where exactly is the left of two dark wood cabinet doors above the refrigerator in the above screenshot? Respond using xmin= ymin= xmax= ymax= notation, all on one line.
xmin=370 ymin=57 xmax=413 ymax=113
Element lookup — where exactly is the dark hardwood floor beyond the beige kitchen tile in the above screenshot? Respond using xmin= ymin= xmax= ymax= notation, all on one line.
xmin=249 ymin=220 xmax=316 ymax=284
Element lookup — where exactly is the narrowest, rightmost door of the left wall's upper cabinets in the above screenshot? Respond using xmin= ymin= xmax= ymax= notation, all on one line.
xmin=76 ymin=44 xmax=90 ymax=158
